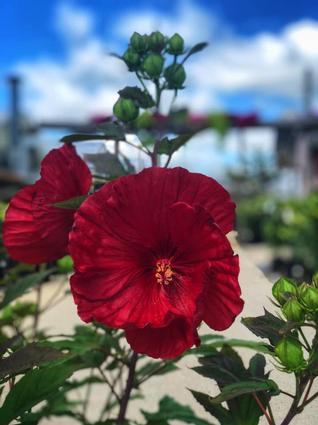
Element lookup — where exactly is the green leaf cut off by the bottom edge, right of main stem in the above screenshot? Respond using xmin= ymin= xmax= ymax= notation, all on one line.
xmin=141 ymin=396 xmax=212 ymax=425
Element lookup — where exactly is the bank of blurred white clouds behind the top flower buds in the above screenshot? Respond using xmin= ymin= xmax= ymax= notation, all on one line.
xmin=12 ymin=0 xmax=318 ymax=121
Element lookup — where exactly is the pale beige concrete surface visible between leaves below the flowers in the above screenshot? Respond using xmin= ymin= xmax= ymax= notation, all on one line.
xmin=21 ymin=235 xmax=318 ymax=425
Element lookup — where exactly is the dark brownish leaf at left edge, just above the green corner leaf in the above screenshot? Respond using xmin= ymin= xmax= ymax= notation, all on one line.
xmin=0 ymin=343 xmax=63 ymax=378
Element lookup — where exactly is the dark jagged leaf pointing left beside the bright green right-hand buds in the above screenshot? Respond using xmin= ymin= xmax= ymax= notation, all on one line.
xmin=242 ymin=309 xmax=286 ymax=346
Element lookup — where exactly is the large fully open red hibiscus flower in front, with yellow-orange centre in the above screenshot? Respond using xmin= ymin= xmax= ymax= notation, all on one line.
xmin=69 ymin=168 xmax=243 ymax=358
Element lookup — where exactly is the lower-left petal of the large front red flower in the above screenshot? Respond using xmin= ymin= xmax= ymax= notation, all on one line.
xmin=71 ymin=269 xmax=176 ymax=328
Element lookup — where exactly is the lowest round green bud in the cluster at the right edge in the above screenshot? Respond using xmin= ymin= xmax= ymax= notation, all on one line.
xmin=275 ymin=337 xmax=306 ymax=372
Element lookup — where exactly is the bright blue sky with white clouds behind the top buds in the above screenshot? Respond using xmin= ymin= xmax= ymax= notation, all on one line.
xmin=0 ymin=0 xmax=318 ymax=120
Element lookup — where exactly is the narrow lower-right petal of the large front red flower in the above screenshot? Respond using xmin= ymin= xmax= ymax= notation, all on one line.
xmin=202 ymin=256 xmax=244 ymax=331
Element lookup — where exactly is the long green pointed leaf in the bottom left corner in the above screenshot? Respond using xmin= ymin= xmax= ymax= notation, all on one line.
xmin=0 ymin=365 xmax=76 ymax=425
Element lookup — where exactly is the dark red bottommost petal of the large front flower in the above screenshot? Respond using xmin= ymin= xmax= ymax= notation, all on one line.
xmin=126 ymin=317 xmax=200 ymax=359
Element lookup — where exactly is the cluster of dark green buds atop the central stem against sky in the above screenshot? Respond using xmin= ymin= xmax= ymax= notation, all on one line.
xmin=113 ymin=31 xmax=190 ymax=122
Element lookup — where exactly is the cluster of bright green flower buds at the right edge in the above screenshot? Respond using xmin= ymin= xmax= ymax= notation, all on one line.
xmin=272 ymin=273 xmax=318 ymax=372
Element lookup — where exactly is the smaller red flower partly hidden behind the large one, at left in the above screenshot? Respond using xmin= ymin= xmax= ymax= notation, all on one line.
xmin=3 ymin=145 xmax=92 ymax=264
